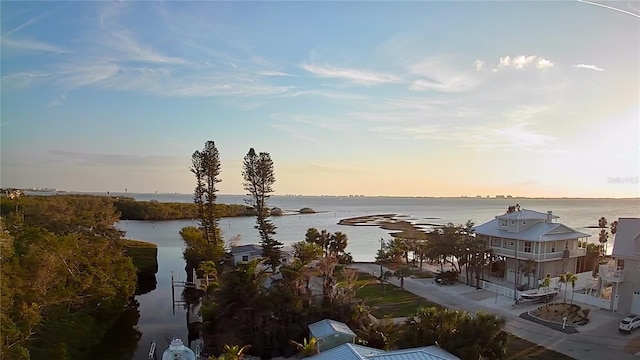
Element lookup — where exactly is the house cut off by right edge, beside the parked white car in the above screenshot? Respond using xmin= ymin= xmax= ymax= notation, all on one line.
xmin=599 ymin=218 xmax=640 ymax=315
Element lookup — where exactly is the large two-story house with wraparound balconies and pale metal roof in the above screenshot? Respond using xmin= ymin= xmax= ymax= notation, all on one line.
xmin=474 ymin=209 xmax=591 ymax=285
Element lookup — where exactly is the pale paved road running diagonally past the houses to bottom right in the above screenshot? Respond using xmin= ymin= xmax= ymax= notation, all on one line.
xmin=351 ymin=264 xmax=640 ymax=360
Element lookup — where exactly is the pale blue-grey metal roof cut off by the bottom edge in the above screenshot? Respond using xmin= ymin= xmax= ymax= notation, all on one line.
xmin=309 ymin=343 xmax=460 ymax=360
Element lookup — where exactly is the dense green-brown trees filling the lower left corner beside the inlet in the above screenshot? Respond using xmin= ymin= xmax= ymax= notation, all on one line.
xmin=0 ymin=196 xmax=137 ymax=360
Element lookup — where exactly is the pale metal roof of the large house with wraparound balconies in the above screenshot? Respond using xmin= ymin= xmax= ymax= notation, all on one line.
xmin=473 ymin=218 xmax=591 ymax=242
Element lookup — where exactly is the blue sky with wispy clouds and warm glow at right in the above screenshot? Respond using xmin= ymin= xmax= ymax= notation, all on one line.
xmin=0 ymin=1 xmax=640 ymax=197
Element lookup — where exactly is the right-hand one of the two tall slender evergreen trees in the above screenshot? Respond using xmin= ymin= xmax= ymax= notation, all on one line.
xmin=242 ymin=148 xmax=282 ymax=271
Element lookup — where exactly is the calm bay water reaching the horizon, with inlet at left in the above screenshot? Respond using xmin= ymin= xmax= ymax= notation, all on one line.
xmin=105 ymin=193 xmax=640 ymax=360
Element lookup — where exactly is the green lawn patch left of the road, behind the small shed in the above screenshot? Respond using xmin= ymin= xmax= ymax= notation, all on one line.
xmin=356 ymin=273 xmax=441 ymax=319
